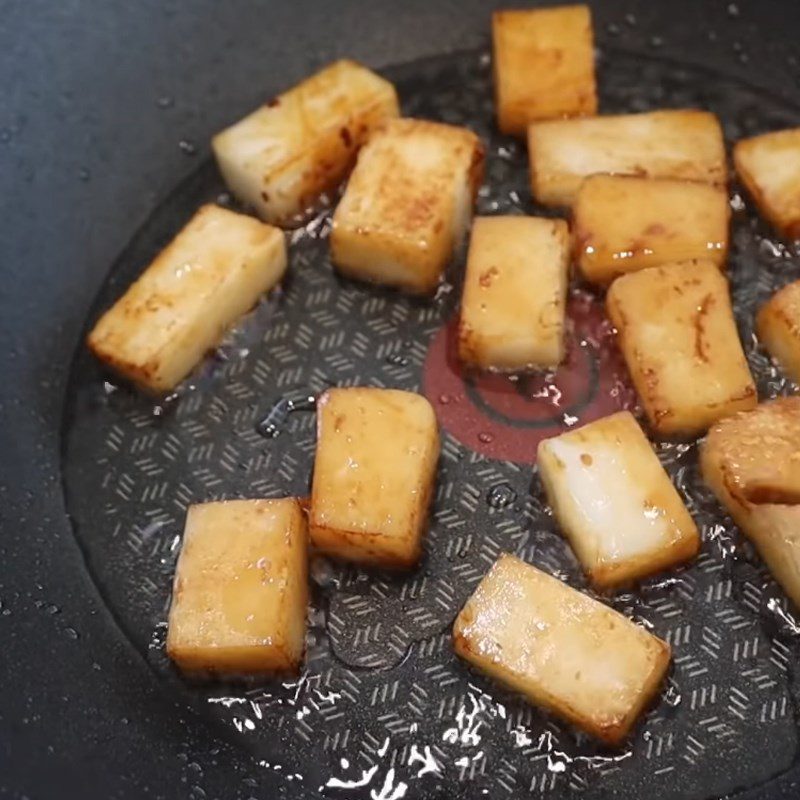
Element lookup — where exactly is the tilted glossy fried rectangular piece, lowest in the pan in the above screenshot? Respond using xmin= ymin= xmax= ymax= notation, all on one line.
xmin=453 ymin=554 xmax=670 ymax=744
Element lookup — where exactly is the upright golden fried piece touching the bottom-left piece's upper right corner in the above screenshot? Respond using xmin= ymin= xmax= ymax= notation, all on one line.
xmin=309 ymin=388 xmax=439 ymax=568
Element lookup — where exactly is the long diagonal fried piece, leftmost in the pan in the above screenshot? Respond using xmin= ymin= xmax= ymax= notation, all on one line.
xmin=87 ymin=205 xmax=286 ymax=393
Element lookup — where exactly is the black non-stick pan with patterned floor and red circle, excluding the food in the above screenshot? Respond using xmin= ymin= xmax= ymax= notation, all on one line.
xmin=7 ymin=0 xmax=800 ymax=800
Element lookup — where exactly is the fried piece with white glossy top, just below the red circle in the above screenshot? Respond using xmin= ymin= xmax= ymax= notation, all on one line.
xmin=537 ymin=411 xmax=700 ymax=589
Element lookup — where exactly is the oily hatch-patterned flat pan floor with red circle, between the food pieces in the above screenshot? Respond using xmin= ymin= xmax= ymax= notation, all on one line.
xmin=0 ymin=1 xmax=800 ymax=798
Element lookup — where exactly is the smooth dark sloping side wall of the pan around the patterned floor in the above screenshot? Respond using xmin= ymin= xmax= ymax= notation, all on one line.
xmin=0 ymin=0 xmax=800 ymax=800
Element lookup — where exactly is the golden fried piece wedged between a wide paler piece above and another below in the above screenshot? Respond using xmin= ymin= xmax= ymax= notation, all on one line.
xmin=572 ymin=175 xmax=730 ymax=286
